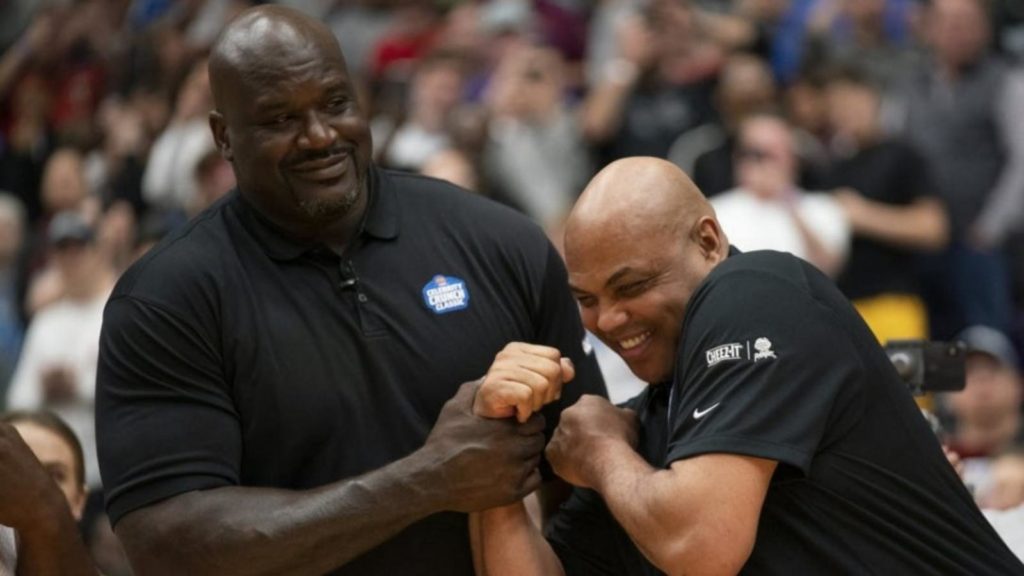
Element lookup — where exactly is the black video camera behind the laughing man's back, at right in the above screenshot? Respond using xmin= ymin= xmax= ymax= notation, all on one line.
xmin=885 ymin=340 xmax=967 ymax=396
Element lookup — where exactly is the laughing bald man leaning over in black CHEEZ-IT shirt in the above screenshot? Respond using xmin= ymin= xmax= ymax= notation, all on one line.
xmin=471 ymin=158 xmax=1024 ymax=576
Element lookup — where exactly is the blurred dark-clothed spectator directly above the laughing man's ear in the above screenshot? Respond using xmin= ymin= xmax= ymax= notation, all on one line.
xmin=669 ymin=54 xmax=778 ymax=198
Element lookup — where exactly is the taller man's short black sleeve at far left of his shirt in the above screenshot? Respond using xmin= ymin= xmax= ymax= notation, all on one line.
xmin=96 ymin=296 xmax=242 ymax=524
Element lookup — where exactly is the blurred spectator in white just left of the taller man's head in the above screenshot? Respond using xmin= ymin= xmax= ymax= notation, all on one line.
xmin=142 ymin=59 xmax=215 ymax=212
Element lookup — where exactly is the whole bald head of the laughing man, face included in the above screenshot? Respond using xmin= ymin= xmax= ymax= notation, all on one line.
xmin=565 ymin=158 xmax=729 ymax=383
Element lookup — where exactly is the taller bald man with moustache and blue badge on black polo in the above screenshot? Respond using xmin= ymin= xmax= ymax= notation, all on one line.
xmin=96 ymin=6 xmax=604 ymax=575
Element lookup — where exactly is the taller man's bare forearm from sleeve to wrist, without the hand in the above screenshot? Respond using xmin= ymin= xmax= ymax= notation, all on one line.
xmin=117 ymin=451 xmax=449 ymax=575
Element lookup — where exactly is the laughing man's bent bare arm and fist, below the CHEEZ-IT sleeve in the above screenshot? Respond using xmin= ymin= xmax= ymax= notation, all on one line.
xmin=547 ymin=396 xmax=776 ymax=575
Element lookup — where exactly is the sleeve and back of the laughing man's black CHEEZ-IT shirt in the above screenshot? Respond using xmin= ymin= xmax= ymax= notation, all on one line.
xmin=665 ymin=251 xmax=1024 ymax=575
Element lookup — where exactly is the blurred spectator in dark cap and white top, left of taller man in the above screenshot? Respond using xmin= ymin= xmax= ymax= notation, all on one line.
xmin=7 ymin=208 xmax=115 ymax=487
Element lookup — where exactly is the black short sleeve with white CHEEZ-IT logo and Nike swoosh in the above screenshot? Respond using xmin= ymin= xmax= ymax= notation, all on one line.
xmin=666 ymin=270 xmax=863 ymax=475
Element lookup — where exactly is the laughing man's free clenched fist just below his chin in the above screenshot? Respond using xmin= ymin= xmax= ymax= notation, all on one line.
xmin=545 ymin=395 xmax=637 ymax=488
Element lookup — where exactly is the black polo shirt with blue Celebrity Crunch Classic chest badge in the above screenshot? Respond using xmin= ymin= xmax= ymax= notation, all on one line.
xmin=96 ymin=163 xmax=604 ymax=575
